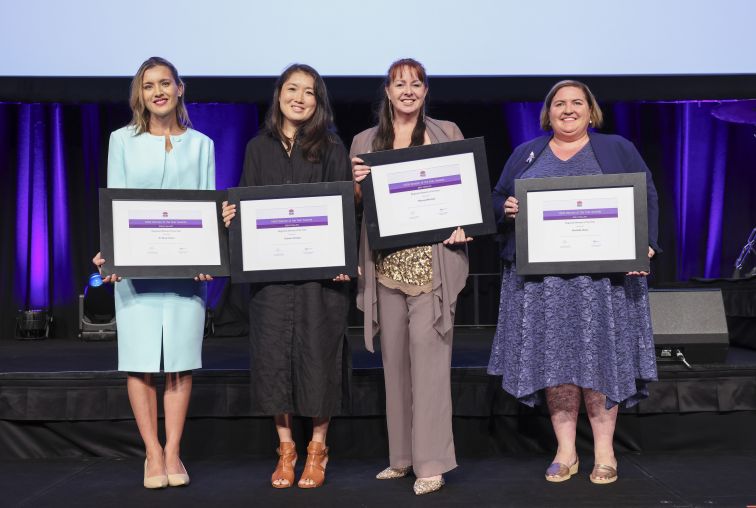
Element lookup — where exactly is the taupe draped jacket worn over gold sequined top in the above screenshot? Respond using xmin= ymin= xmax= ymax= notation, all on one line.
xmin=349 ymin=117 xmax=469 ymax=352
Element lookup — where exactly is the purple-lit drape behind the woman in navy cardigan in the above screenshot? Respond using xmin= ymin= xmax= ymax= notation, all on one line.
xmin=503 ymin=101 xmax=756 ymax=280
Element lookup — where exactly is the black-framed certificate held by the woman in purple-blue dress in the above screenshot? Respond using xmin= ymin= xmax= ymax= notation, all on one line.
xmin=515 ymin=173 xmax=649 ymax=275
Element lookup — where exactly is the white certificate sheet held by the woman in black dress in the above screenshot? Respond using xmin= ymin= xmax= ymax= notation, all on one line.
xmin=240 ymin=195 xmax=346 ymax=272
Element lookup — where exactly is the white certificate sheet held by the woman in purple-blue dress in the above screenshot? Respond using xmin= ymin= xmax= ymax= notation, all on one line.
xmin=528 ymin=187 xmax=635 ymax=263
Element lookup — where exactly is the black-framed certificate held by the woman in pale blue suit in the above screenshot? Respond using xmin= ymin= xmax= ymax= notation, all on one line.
xmin=100 ymin=189 xmax=229 ymax=279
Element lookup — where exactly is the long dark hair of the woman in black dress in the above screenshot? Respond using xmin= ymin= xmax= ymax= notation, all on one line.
xmin=265 ymin=64 xmax=336 ymax=162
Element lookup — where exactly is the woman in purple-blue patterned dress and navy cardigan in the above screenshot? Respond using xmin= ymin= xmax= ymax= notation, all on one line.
xmin=488 ymin=81 xmax=660 ymax=484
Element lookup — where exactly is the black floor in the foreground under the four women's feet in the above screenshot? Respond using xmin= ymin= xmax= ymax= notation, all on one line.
xmin=0 ymin=452 xmax=756 ymax=508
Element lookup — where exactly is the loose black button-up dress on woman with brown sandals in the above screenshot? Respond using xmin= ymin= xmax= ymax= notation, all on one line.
xmin=239 ymin=132 xmax=352 ymax=417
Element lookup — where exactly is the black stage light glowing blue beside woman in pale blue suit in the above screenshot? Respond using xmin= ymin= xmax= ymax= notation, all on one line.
xmin=79 ymin=273 xmax=117 ymax=341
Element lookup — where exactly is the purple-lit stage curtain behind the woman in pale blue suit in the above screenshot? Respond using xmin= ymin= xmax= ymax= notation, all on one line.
xmin=0 ymin=103 xmax=259 ymax=340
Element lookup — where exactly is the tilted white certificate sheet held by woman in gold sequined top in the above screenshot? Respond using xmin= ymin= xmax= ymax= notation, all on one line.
xmin=371 ymin=152 xmax=483 ymax=237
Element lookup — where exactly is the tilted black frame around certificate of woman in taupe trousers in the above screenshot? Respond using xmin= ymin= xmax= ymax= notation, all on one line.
xmin=358 ymin=137 xmax=496 ymax=249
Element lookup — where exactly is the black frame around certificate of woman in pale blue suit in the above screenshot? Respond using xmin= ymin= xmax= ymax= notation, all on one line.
xmin=99 ymin=189 xmax=230 ymax=279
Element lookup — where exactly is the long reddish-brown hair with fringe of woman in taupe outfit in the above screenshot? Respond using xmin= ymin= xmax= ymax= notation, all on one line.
xmin=373 ymin=58 xmax=428 ymax=152
